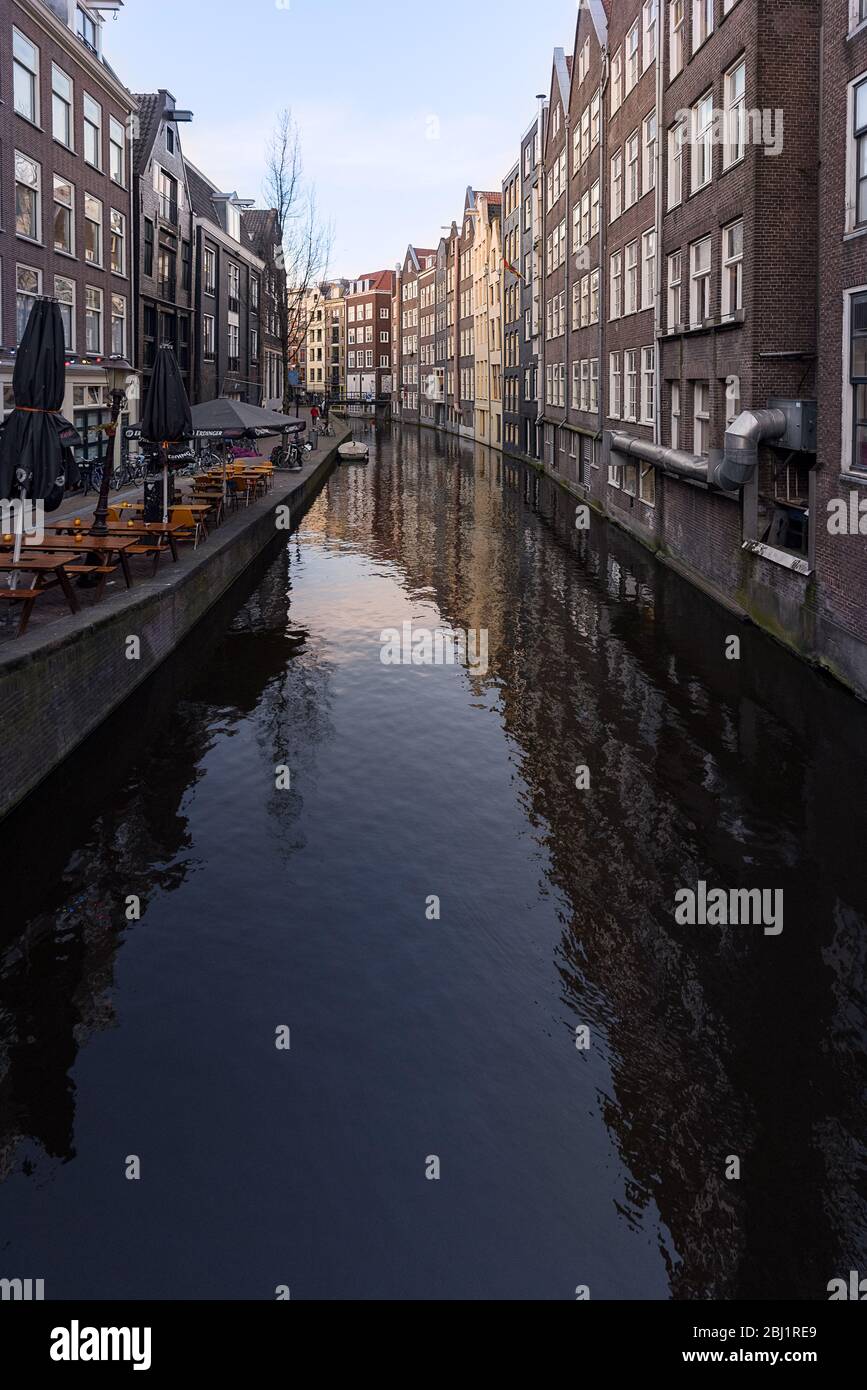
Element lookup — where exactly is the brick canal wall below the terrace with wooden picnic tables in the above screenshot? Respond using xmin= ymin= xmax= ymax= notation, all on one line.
xmin=0 ymin=430 xmax=349 ymax=820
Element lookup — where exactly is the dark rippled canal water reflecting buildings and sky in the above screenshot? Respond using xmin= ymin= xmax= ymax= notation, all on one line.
xmin=0 ymin=431 xmax=867 ymax=1300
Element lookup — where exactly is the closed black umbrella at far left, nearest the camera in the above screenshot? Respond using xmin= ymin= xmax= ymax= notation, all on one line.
xmin=0 ymin=299 xmax=81 ymax=581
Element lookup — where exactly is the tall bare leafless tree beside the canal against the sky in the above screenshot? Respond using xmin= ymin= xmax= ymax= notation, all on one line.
xmin=264 ymin=110 xmax=333 ymax=414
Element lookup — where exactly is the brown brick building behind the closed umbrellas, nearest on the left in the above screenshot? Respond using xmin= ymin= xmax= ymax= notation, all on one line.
xmin=0 ymin=0 xmax=138 ymax=459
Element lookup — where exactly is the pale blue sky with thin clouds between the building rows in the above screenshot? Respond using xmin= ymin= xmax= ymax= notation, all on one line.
xmin=104 ymin=0 xmax=578 ymax=279
